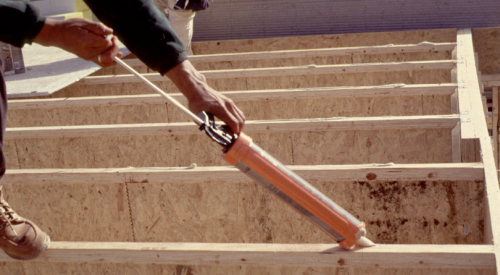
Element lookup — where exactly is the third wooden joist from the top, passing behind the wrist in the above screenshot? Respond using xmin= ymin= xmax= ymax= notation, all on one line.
xmin=9 ymin=83 xmax=457 ymax=110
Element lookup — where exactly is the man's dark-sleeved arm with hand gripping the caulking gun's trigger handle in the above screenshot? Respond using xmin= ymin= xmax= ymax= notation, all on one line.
xmin=85 ymin=0 xmax=245 ymax=133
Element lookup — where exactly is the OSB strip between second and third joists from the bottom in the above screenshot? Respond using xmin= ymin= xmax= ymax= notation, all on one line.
xmin=1 ymin=129 xmax=451 ymax=169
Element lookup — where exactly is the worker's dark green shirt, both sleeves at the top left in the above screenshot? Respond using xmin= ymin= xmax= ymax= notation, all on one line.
xmin=0 ymin=0 xmax=187 ymax=74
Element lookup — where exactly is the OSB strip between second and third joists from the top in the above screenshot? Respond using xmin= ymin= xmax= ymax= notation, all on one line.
xmin=44 ymin=70 xmax=451 ymax=98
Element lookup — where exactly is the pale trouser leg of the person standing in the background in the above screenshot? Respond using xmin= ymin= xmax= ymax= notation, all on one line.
xmin=166 ymin=0 xmax=195 ymax=55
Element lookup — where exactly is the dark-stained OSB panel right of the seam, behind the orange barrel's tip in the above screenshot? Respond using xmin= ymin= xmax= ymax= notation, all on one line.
xmin=128 ymin=179 xmax=484 ymax=244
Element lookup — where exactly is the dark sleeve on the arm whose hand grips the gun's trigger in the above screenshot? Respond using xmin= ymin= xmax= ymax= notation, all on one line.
xmin=85 ymin=0 xmax=187 ymax=75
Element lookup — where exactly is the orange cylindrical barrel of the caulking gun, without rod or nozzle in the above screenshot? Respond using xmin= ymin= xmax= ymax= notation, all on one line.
xmin=223 ymin=133 xmax=366 ymax=249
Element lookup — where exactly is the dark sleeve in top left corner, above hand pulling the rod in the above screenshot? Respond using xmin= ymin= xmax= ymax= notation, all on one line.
xmin=0 ymin=0 xmax=45 ymax=47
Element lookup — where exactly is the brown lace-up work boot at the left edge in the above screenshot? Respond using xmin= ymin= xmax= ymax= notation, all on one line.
xmin=0 ymin=186 xmax=50 ymax=260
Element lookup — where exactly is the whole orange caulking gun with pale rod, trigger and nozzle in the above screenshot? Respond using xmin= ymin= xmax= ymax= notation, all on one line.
xmin=115 ymin=57 xmax=374 ymax=249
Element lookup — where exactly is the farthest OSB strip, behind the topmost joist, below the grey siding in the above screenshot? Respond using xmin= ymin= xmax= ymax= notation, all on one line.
xmin=192 ymin=29 xmax=457 ymax=54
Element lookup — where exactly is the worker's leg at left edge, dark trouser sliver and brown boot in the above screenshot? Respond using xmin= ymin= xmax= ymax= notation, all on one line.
xmin=0 ymin=71 xmax=50 ymax=260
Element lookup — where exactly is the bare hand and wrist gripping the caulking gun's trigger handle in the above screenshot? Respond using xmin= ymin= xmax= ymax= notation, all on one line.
xmin=166 ymin=60 xmax=245 ymax=134
